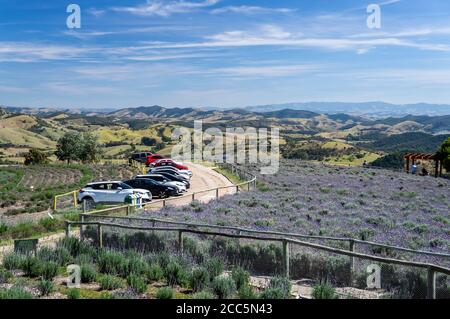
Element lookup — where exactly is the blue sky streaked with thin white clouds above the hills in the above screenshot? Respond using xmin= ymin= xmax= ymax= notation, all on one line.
xmin=0 ymin=0 xmax=450 ymax=108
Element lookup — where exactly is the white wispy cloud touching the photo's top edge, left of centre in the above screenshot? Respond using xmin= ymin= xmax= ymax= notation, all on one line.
xmin=111 ymin=0 xmax=220 ymax=17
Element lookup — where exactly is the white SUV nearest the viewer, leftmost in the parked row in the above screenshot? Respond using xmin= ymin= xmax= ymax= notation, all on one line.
xmin=78 ymin=181 xmax=152 ymax=208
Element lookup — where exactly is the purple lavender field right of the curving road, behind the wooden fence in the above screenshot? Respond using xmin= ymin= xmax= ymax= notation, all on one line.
xmin=148 ymin=160 xmax=450 ymax=258
